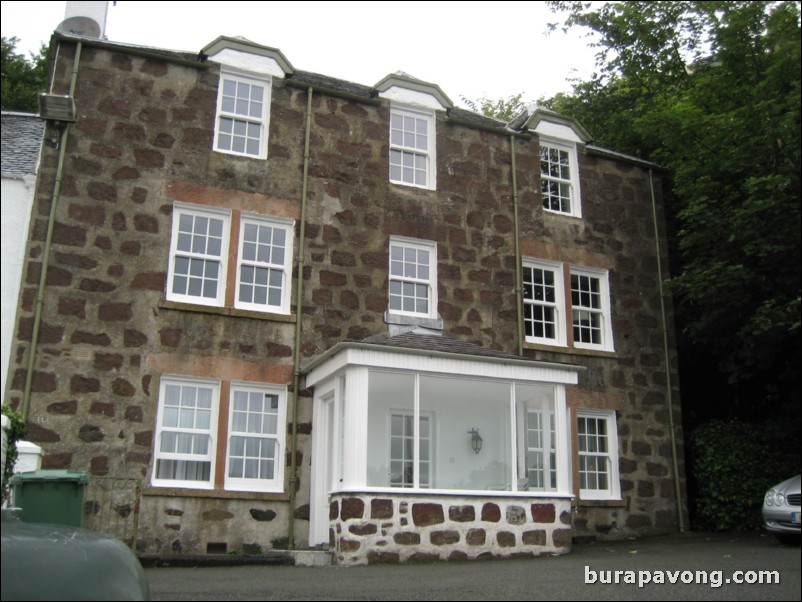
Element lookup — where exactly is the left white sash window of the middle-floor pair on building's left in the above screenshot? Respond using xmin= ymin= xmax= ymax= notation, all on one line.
xmin=166 ymin=202 xmax=231 ymax=307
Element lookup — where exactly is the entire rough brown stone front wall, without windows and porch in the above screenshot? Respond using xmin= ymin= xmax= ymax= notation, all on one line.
xmin=3 ymin=36 xmax=682 ymax=552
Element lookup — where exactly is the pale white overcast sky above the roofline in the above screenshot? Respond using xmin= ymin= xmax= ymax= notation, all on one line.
xmin=0 ymin=1 xmax=594 ymax=104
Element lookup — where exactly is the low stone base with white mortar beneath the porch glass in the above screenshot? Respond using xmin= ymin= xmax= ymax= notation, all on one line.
xmin=329 ymin=493 xmax=571 ymax=565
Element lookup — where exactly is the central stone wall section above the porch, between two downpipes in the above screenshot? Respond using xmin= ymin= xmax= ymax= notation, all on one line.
xmin=295 ymin=101 xmax=534 ymax=353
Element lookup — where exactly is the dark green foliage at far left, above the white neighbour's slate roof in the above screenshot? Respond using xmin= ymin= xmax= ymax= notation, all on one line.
xmin=2 ymin=37 xmax=47 ymax=113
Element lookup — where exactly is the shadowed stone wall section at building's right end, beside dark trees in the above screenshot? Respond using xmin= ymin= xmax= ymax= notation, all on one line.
xmin=522 ymin=151 xmax=687 ymax=539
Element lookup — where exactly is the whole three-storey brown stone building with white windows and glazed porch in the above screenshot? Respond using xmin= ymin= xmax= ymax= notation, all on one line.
xmin=6 ymin=28 xmax=684 ymax=564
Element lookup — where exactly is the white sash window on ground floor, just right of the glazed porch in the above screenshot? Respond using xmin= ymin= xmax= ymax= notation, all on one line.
xmin=576 ymin=409 xmax=621 ymax=500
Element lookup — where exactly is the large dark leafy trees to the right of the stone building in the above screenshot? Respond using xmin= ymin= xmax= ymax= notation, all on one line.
xmin=546 ymin=1 xmax=800 ymax=426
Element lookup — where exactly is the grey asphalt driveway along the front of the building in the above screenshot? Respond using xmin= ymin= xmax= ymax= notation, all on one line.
xmin=146 ymin=533 xmax=802 ymax=601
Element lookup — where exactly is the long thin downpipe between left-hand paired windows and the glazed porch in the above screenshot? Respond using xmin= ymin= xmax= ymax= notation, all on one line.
xmin=287 ymin=86 xmax=312 ymax=550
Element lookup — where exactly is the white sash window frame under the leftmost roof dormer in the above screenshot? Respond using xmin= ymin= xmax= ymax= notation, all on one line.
xmin=214 ymin=68 xmax=272 ymax=159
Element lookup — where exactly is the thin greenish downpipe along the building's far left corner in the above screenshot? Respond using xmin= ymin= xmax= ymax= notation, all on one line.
xmin=20 ymin=40 xmax=83 ymax=422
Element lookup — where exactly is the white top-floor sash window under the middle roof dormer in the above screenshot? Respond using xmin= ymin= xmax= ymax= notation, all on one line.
xmin=388 ymin=104 xmax=437 ymax=190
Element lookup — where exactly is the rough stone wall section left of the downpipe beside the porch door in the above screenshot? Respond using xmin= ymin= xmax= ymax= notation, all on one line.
xmin=9 ymin=43 xmax=311 ymax=553
